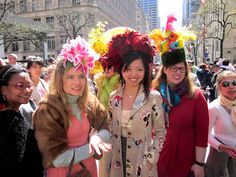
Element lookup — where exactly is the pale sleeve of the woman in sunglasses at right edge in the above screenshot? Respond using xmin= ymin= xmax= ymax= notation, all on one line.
xmin=208 ymin=101 xmax=221 ymax=150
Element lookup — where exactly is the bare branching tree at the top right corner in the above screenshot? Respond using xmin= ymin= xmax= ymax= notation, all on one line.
xmin=200 ymin=0 xmax=236 ymax=58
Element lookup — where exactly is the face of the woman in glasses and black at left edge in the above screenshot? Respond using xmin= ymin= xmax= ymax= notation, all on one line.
xmin=2 ymin=72 xmax=33 ymax=106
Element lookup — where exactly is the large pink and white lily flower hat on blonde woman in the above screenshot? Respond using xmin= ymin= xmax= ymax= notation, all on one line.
xmin=59 ymin=36 xmax=98 ymax=75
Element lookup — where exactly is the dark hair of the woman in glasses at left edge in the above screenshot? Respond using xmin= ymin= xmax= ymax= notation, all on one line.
xmin=0 ymin=65 xmax=28 ymax=106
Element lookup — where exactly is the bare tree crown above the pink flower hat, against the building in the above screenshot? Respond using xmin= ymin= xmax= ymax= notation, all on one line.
xmin=55 ymin=10 xmax=90 ymax=39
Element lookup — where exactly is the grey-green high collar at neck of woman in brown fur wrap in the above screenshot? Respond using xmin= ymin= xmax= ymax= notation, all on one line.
xmin=66 ymin=94 xmax=82 ymax=120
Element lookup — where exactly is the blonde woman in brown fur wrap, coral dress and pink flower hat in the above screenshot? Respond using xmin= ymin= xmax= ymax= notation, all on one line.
xmin=33 ymin=36 xmax=111 ymax=177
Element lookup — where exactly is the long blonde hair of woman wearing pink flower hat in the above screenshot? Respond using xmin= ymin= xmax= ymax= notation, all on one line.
xmin=49 ymin=59 xmax=89 ymax=110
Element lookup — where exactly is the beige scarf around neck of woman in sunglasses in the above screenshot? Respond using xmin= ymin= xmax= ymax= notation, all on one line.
xmin=218 ymin=94 xmax=236 ymax=126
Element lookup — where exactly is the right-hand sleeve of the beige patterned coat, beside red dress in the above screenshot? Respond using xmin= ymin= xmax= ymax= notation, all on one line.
xmin=147 ymin=94 xmax=166 ymax=164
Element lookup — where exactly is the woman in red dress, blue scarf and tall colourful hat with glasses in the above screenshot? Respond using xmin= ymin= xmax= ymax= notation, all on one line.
xmin=153 ymin=15 xmax=209 ymax=177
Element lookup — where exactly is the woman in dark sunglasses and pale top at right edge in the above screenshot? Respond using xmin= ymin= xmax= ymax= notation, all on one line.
xmin=206 ymin=71 xmax=236 ymax=177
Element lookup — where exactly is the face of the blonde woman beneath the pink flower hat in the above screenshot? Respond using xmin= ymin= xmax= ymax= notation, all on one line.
xmin=63 ymin=67 xmax=87 ymax=96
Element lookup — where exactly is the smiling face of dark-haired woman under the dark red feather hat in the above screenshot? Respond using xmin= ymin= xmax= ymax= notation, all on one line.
xmin=122 ymin=59 xmax=145 ymax=86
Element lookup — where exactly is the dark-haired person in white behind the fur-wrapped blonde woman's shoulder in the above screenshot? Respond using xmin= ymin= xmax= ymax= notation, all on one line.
xmin=27 ymin=56 xmax=48 ymax=105
